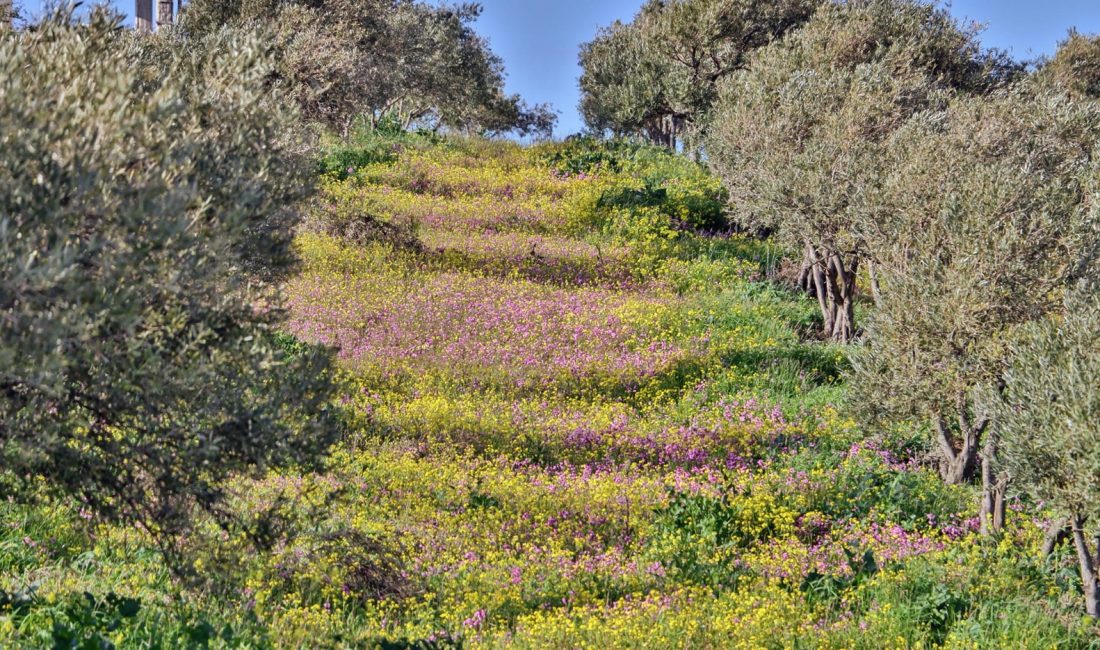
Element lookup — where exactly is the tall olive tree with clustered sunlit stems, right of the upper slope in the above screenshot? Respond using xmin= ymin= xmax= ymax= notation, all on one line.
xmin=706 ymin=0 xmax=996 ymax=342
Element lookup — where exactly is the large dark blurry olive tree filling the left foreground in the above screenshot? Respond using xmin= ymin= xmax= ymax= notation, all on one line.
xmin=0 ymin=10 xmax=336 ymax=550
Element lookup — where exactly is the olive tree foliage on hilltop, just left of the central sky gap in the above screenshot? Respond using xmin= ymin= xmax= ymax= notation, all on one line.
xmin=180 ymin=0 xmax=557 ymax=136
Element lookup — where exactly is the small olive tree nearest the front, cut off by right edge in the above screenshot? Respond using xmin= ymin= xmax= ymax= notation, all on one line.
xmin=990 ymin=287 xmax=1100 ymax=616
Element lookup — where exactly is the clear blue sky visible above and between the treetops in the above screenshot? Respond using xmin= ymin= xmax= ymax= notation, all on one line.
xmin=15 ymin=0 xmax=1100 ymax=135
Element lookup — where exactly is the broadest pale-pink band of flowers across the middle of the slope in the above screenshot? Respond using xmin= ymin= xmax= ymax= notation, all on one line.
xmin=290 ymin=273 xmax=685 ymax=387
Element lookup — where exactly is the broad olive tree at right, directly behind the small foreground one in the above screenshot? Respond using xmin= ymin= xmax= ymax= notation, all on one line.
xmin=851 ymin=86 xmax=1100 ymax=503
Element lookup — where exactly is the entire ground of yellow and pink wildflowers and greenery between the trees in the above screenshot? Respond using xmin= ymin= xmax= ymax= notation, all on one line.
xmin=0 ymin=136 xmax=1098 ymax=648
